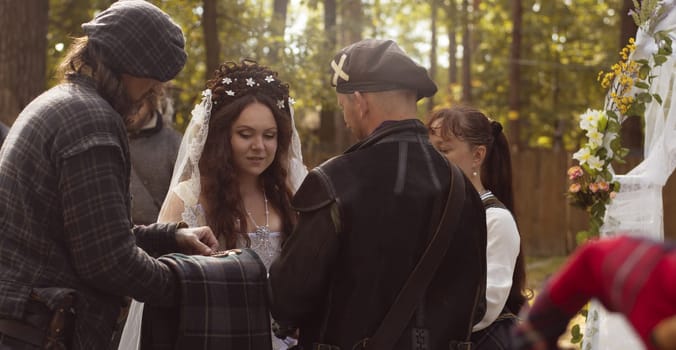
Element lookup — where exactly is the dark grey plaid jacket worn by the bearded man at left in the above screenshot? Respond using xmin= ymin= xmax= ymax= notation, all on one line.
xmin=0 ymin=75 xmax=181 ymax=349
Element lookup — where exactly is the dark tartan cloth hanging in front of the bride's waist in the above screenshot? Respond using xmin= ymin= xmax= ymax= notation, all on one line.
xmin=141 ymin=249 xmax=272 ymax=350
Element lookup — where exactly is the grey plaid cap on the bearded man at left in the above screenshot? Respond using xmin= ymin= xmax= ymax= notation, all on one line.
xmin=82 ymin=0 xmax=187 ymax=82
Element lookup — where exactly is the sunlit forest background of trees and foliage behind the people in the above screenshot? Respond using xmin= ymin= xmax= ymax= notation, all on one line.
xmin=0 ymin=0 xmax=676 ymax=255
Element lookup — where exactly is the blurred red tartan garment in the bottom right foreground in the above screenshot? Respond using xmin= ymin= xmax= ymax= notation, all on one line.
xmin=515 ymin=236 xmax=676 ymax=349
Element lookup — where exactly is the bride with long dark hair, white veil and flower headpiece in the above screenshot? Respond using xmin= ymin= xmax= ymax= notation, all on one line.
xmin=119 ymin=60 xmax=307 ymax=350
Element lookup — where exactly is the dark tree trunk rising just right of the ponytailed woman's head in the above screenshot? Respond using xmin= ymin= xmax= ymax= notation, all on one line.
xmin=508 ymin=0 xmax=524 ymax=152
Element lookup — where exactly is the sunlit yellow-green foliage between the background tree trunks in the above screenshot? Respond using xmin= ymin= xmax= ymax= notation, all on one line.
xmin=47 ymin=0 xmax=640 ymax=163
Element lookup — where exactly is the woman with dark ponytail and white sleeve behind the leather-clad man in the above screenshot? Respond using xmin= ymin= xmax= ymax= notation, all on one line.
xmin=427 ymin=106 xmax=527 ymax=349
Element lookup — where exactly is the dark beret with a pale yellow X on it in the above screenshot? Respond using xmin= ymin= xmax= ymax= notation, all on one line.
xmin=331 ymin=39 xmax=437 ymax=99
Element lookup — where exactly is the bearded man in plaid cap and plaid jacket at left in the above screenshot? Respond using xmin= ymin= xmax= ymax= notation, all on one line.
xmin=0 ymin=0 xmax=217 ymax=349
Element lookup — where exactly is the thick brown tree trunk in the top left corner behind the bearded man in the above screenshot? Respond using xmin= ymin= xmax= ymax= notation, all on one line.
xmin=0 ymin=0 xmax=49 ymax=125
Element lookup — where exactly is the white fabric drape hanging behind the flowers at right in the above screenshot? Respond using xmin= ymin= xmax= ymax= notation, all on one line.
xmin=582 ymin=0 xmax=676 ymax=350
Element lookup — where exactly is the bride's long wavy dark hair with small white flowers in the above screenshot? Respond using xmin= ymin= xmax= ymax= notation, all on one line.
xmin=199 ymin=60 xmax=295 ymax=249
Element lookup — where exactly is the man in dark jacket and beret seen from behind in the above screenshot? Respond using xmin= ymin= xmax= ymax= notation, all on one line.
xmin=270 ymin=39 xmax=486 ymax=350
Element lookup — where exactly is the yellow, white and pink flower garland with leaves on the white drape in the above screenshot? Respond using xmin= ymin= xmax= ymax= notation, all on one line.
xmin=566 ymin=0 xmax=672 ymax=242
